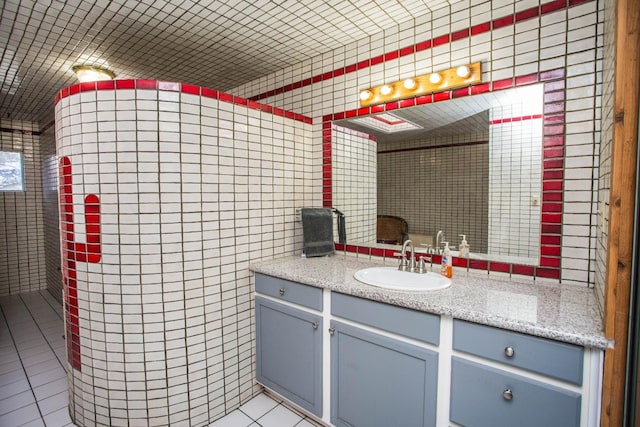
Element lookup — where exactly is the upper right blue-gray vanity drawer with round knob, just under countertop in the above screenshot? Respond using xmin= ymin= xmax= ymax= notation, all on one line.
xmin=453 ymin=320 xmax=584 ymax=385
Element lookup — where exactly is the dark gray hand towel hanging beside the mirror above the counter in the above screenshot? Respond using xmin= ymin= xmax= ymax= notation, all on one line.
xmin=301 ymin=208 xmax=335 ymax=257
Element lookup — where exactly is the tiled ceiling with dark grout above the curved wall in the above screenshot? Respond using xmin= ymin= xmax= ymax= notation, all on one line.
xmin=0 ymin=0 xmax=455 ymax=124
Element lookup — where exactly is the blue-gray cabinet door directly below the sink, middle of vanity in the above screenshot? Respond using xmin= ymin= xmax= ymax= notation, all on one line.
xmin=331 ymin=321 xmax=438 ymax=427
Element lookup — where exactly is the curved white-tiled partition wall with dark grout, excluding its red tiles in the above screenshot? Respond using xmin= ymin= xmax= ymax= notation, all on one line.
xmin=56 ymin=86 xmax=321 ymax=426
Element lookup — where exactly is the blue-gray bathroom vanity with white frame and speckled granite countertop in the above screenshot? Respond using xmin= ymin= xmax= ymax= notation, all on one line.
xmin=252 ymin=256 xmax=608 ymax=427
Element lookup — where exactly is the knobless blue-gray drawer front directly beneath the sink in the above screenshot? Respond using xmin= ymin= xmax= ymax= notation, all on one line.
xmin=331 ymin=292 xmax=440 ymax=345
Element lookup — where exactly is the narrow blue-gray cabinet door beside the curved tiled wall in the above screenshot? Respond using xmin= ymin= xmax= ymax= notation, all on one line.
xmin=256 ymin=296 xmax=322 ymax=417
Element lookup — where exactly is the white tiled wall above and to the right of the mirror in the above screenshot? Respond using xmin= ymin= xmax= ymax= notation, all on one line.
xmin=233 ymin=0 xmax=604 ymax=286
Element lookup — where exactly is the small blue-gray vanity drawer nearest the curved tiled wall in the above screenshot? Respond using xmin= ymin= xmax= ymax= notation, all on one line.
xmin=256 ymin=273 xmax=322 ymax=311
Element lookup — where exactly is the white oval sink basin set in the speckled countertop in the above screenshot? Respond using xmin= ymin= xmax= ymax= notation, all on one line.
xmin=353 ymin=267 xmax=451 ymax=291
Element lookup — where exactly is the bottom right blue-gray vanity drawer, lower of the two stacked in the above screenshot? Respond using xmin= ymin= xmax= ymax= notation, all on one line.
xmin=450 ymin=357 xmax=581 ymax=427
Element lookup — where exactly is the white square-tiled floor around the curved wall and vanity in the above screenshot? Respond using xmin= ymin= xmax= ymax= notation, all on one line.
xmin=0 ymin=291 xmax=320 ymax=427
